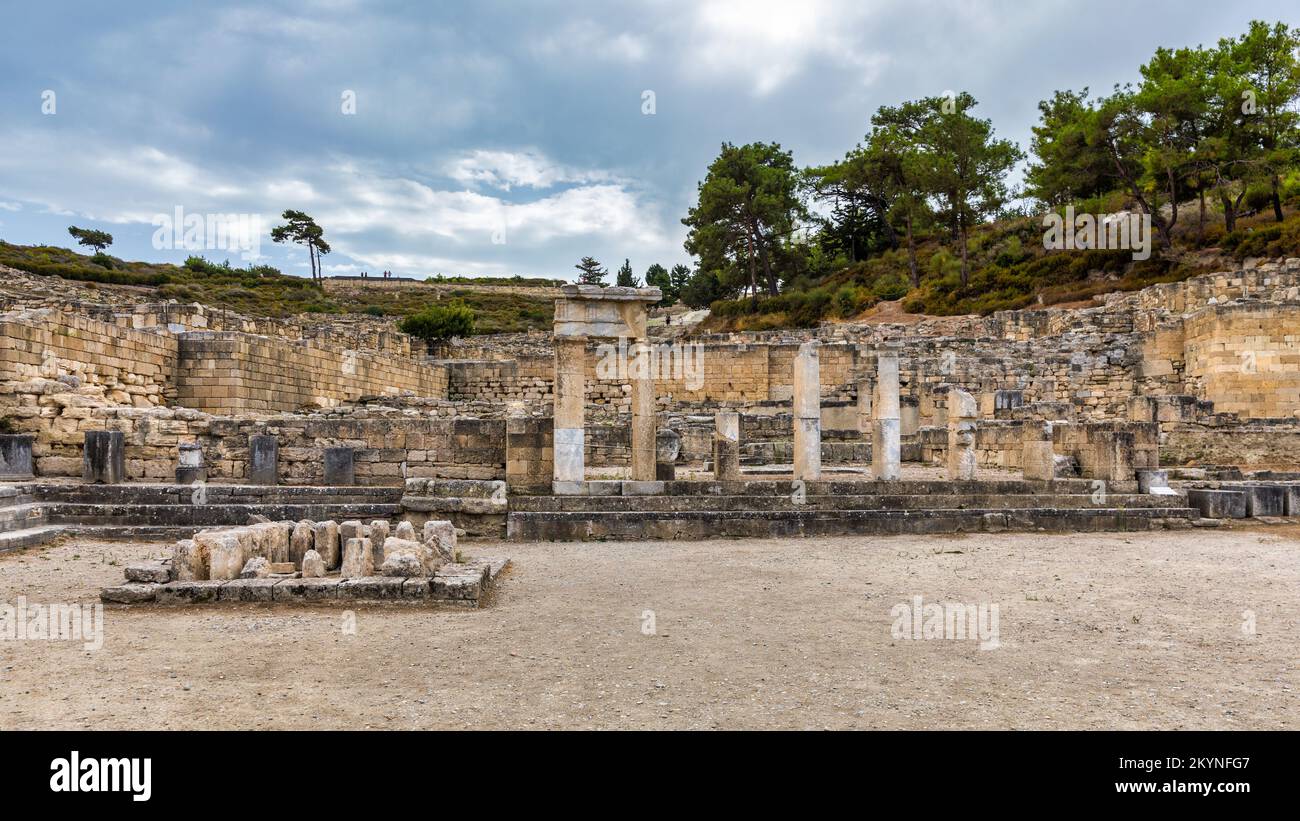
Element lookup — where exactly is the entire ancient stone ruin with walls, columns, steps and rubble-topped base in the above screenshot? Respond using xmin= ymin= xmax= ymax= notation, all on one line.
xmin=0 ymin=259 xmax=1300 ymax=610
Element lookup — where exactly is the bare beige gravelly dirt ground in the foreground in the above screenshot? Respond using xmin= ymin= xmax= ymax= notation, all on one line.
xmin=0 ymin=526 xmax=1300 ymax=729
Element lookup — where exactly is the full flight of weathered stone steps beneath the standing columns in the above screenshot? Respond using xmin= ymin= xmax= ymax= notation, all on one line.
xmin=507 ymin=479 xmax=1197 ymax=540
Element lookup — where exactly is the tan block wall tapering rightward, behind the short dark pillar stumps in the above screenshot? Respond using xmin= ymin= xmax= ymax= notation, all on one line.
xmin=177 ymin=333 xmax=447 ymax=413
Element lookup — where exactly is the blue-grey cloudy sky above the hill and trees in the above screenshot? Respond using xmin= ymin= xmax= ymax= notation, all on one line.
xmin=0 ymin=0 xmax=1284 ymax=278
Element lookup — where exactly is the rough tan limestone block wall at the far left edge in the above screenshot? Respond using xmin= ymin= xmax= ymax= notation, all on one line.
xmin=0 ymin=310 xmax=177 ymax=408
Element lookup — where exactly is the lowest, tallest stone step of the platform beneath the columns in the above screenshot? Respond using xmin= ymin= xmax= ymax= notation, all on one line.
xmin=507 ymin=508 xmax=1196 ymax=542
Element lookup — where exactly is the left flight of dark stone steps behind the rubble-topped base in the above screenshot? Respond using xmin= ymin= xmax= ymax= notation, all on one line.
xmin=0 ymin=483 xmax=402 ymax=549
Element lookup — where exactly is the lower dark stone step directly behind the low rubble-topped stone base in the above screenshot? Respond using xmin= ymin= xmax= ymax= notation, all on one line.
xmin=47 ymin=503 xmax=402 ymax=530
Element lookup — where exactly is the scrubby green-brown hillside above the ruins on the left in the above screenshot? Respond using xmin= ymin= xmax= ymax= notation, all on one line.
xmin=0 ymin=240 xmax=554 ymax=334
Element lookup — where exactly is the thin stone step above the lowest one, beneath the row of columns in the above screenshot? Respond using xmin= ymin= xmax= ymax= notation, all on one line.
xmin=510 ymin=494 xmax=1184 ymax=513
